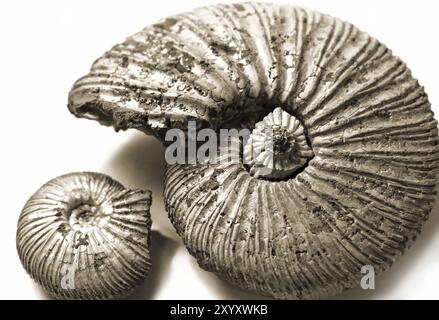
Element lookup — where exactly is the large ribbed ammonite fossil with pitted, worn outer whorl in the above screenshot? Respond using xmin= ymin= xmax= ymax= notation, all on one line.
xmin=69 ymin=3 xmax=439 ymax=298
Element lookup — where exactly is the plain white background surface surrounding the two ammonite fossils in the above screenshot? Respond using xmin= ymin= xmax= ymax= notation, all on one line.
xmin=0 ymin=0 xmax=439 ymax=299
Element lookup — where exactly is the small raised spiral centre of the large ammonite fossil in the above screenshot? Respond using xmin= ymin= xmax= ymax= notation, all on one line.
xmin=244 ymin=107 xmax=314 ymax=180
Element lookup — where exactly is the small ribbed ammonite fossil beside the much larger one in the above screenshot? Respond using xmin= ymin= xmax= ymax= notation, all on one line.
xmin=17 ymin=172 xmax=151 ymax=299
